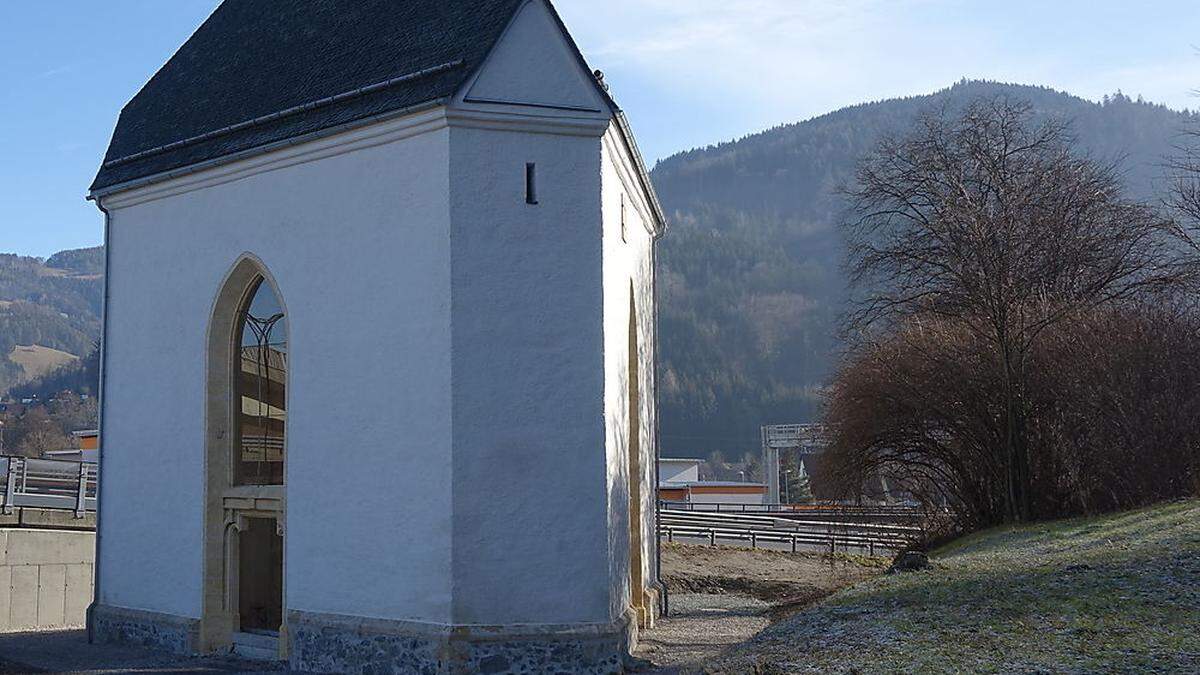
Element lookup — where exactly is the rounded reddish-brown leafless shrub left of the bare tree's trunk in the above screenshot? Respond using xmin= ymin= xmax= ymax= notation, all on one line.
xmin=821 ymin=318 xmax=1022 ymax=527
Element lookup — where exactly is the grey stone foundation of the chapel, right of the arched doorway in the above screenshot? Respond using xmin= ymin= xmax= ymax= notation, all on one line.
xmin=288 ymin=611 xmax=631 ymax=675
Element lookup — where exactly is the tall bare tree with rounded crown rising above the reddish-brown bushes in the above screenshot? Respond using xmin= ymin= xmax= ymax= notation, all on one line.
xmin=844 ymin=97 xmax=1172 ymax=520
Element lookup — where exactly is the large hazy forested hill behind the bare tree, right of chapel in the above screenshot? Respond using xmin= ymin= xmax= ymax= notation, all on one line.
xmin=653 ymin=82 xmax=1193 ymax=459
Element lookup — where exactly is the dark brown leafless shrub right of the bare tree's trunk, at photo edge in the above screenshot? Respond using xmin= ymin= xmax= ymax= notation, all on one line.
xmin=1031 ymin=303 xmax=1200 ymax=516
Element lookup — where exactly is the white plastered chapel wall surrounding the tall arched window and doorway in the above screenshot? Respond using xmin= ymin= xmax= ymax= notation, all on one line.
xmin=100 ymin=112 xmax=450 ymax=621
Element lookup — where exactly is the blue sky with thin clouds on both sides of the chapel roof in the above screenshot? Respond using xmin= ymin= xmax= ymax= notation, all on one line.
xmin=0 ymin=0 xmax=1200 ymax=256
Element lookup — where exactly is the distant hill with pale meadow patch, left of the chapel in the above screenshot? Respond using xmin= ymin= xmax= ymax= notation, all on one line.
xmin=0 ymin=247 xmax=103 ymax=395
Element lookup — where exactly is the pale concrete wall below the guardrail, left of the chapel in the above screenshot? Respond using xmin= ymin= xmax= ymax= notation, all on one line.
xmin=0 ymin=527 xmax=96 ymax=632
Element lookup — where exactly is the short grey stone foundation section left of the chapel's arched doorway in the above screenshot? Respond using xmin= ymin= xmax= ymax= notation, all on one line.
xmin=88 ymin=604 xmax=200 ymax=655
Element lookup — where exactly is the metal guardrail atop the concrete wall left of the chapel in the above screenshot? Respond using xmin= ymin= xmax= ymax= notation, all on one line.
xmin=0 ymin=456 xmax=98 ymax=518
